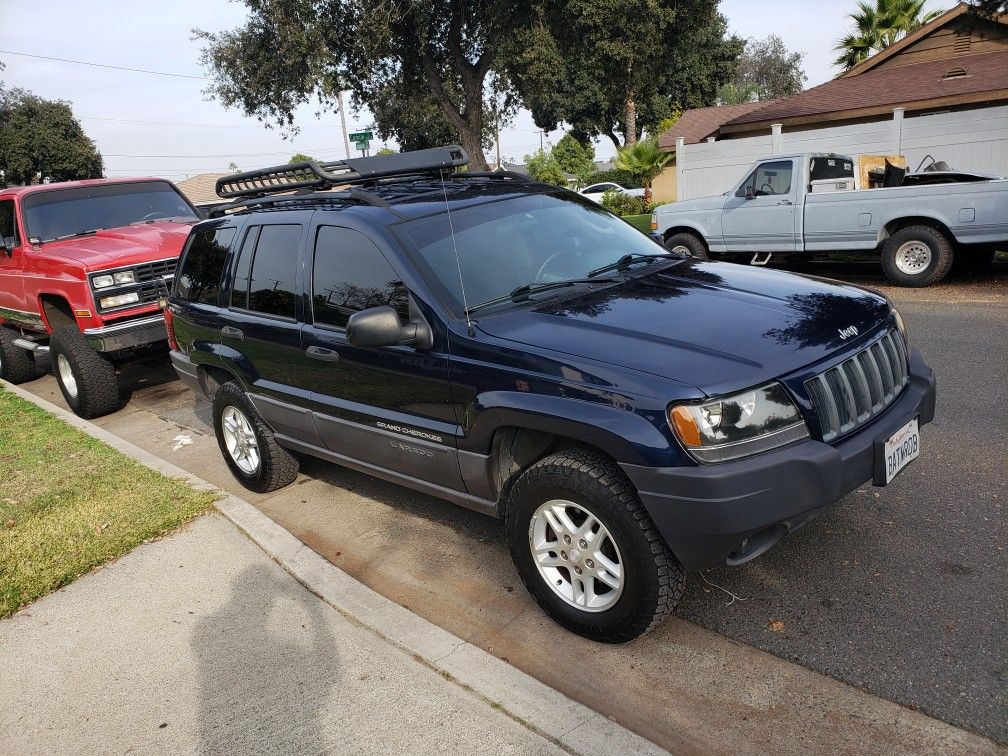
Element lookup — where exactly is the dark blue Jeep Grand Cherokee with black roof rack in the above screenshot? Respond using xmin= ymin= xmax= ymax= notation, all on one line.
xmin=166 ymin=147 xmax=934 ymax=642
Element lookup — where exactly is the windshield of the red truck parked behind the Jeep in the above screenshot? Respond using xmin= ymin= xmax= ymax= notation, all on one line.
xmin=23 ymin=181 xmax=197 ymax=242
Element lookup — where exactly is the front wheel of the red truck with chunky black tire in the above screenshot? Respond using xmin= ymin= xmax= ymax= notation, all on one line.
xmin=49 ymin=326 xmax=123 ymax=419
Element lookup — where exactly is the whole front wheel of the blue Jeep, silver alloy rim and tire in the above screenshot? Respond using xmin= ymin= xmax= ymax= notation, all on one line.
xmin=506 ymin=449 xmax=685 ymax=643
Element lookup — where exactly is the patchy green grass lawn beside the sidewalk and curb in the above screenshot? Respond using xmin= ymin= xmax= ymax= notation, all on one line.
xmin=0 ymin=388 xmax=215 ymax=617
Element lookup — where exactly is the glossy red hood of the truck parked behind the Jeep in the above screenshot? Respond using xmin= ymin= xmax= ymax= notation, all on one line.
xmin=35 ymin=219 xmax=197 ymax=271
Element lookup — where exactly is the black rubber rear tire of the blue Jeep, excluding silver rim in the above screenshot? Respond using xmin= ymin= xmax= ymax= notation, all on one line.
xmin=208 ymin=381 xmax=299 ymax=494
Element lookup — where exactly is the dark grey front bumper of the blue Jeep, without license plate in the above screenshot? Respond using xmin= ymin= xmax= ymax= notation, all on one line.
xmin=620 ymin=353 xmax=934 ymax=570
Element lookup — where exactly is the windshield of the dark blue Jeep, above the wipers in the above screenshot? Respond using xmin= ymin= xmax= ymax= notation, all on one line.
xmin=397 ymin=195 xmax=677 ymax=314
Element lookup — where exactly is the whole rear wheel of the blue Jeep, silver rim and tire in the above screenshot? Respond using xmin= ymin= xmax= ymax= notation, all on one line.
xmin=208 ymin=381 xmax=298 ymax=494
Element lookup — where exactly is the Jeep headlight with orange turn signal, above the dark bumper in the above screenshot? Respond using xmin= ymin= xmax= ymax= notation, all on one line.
xmin=668 ymin=383 xmax=808 ymax=462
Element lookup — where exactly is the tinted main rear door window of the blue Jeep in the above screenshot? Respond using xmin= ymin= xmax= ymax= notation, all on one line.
xmin=248 ymin=226 xmax=301 ymax=320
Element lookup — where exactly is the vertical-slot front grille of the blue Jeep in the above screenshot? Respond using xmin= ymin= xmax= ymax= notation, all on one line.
xmin=805 ymin=329 xmax=909 ymax=442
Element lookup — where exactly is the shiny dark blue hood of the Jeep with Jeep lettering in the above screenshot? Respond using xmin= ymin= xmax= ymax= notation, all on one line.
xmin=471 ymin=261 xmax=889 ymax=395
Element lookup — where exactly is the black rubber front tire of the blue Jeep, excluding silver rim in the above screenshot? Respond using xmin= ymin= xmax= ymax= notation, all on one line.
xmin=506 ymin=450 xmax=685 ymax=643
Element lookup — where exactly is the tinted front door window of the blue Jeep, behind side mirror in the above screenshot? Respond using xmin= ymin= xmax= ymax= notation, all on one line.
xmin=311 ymin=226 xmax=408 ymax=328
